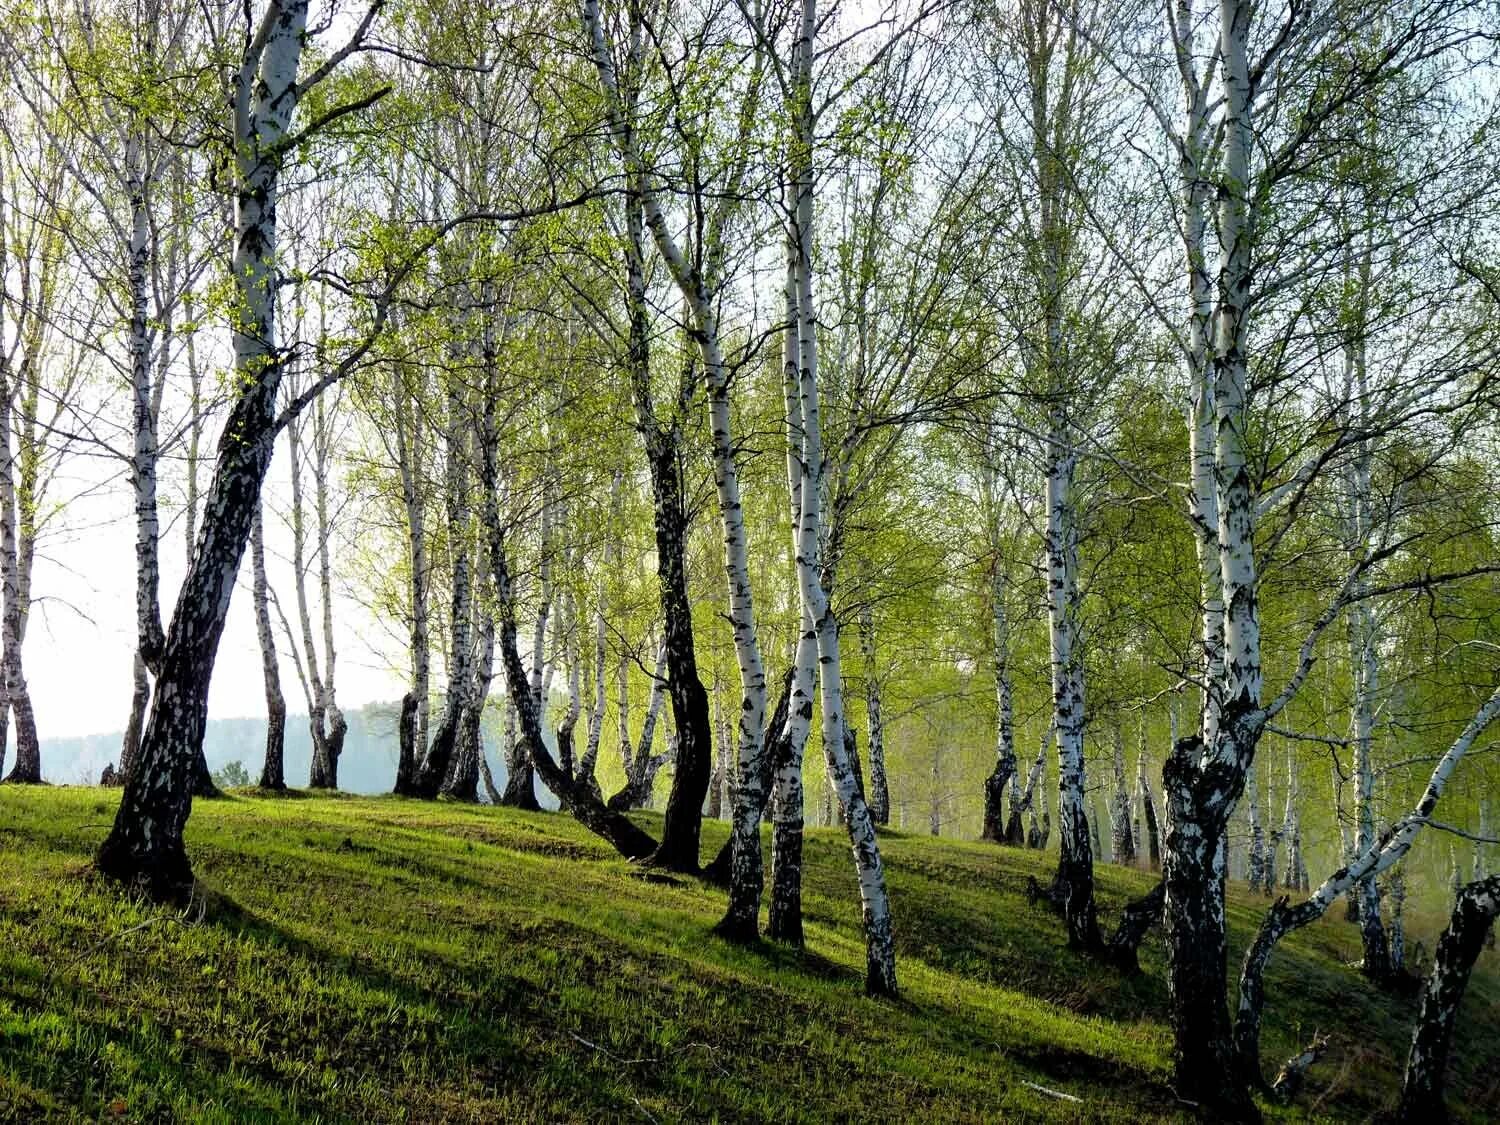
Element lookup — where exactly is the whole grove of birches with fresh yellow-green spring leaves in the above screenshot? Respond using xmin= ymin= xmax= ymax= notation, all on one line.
xmin=0 ymin=0 xmax=1500 ymax=1121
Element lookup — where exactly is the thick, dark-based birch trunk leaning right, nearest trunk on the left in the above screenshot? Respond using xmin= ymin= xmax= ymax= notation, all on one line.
xmin=96 ymin=0 xmax=308 ymax=899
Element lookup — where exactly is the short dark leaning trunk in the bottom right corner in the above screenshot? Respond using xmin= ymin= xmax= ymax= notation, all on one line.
xmin=1397 ymin=876 xmax=1500 ymax=1125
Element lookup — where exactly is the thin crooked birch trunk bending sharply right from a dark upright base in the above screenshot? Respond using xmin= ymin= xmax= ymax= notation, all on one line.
xmin=1235 ymin=687 xmax=1500 ymax=1085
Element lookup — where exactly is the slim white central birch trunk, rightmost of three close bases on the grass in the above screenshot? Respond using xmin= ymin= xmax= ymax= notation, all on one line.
xmin=789 ymin=13 xmax=897 ymax=995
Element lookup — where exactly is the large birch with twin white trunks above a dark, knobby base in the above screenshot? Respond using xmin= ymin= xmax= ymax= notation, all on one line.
xmin=1151 ymin=0 xmax=1500 ymax=1118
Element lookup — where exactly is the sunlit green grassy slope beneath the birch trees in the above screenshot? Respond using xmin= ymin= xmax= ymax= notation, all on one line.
xmin=0 ymin=786 xmax=1500 ymax=1122
